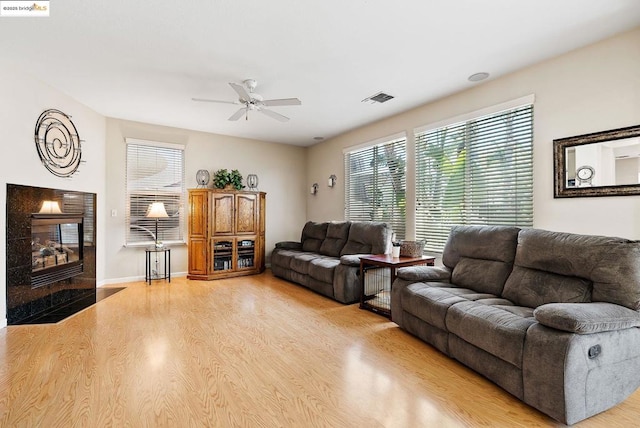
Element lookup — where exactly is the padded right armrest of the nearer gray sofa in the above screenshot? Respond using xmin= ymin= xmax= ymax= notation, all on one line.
xmin=533 ymin=302 xmax=640 ymax=334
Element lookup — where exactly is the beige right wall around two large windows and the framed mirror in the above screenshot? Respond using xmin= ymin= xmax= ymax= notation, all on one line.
xmin=307 ymin=28 xmax=640 ymax=239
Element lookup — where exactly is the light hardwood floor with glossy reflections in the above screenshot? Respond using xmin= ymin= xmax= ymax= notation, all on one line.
xmin=0 ymin=271 xmax=640 ymax=427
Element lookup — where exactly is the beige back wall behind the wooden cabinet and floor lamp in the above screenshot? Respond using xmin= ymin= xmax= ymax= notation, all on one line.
xmin=105 ymin=119 xmax=306 ymax=283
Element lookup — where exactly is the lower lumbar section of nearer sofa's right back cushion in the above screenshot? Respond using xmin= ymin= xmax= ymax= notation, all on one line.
xmin=502 ymin=266 xmax=592 ymax=308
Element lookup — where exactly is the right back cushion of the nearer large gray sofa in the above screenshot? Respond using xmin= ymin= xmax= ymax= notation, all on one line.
xmin=503 ymin=229 xmax=640 ymax=310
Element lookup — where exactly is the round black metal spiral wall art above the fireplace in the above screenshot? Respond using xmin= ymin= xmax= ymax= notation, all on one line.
xmin=34 ymin=109 xmax=82 ymax=177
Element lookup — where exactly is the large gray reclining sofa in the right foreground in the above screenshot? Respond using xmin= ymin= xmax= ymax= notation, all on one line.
xmin=391 ymin=226 xmax=640 ymax=424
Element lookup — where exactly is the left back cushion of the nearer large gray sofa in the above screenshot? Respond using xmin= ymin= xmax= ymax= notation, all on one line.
xmin=442 ymin=226 xmax=520 ymax=295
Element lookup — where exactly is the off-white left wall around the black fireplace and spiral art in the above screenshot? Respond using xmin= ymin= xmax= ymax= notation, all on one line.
xmin=0 ymin=59 xmax=106 ymax=327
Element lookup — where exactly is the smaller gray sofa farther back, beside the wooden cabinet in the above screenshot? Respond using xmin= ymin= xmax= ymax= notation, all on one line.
xmin=271 ymin=221 xmax=392 ymax=303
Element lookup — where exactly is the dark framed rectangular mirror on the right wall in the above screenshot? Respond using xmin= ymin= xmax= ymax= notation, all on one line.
xmin=553 ymin=125 xmax=640 ymax=198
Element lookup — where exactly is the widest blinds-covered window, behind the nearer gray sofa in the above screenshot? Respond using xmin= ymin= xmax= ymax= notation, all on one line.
xmin=416 ymin=105 xmax=533 ymax=252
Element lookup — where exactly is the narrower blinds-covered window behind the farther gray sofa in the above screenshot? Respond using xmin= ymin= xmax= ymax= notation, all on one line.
xmin=344 ymin=137 xmax=407 ymax=239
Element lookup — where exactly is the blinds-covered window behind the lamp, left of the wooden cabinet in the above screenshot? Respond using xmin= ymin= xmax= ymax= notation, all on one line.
xmin=126 ymin=139 xmax=186 ymax=244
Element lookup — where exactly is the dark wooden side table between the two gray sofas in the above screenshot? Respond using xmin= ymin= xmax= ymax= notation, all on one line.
xmin=360 ymin=254 xmax=436 ymax=319
